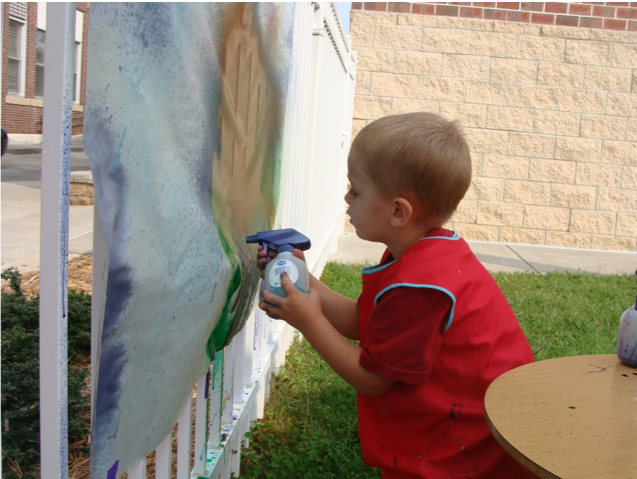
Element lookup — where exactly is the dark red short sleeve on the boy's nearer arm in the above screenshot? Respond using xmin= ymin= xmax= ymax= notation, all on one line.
xmin=360 ymin=287 xmax=452 ymax=384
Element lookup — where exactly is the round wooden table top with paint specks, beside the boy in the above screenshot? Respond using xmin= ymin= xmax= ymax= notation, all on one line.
xmin=485 ymin=354 xmax=637 ymax=479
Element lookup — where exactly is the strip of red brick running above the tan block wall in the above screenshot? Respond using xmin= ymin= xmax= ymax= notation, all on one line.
xmin=352 ymin=2 xmax=637 ymax=32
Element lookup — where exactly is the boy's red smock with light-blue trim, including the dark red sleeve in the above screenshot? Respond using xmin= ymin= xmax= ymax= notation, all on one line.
xmin=358 ymin=229 xmax=533 ymax=479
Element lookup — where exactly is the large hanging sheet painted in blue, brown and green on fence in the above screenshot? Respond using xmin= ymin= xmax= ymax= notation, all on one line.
xmin=84 ymin=3 xmax=294 ymax=479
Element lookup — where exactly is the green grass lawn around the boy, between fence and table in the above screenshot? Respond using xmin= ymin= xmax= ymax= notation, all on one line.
xmin=236 ymin=263 xmax=635 ymax=479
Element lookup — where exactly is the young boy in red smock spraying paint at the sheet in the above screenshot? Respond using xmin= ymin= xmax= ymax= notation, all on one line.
xmin=257 ymin=113 xmax=533 ymax=479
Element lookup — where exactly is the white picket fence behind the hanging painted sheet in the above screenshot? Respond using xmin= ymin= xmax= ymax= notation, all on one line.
xmin=41 ymin=2 xmax=356 ymax=479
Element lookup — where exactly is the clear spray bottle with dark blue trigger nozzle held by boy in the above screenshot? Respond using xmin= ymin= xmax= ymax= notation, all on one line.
xmin=246 ymin=228 xmax=312 ymax=296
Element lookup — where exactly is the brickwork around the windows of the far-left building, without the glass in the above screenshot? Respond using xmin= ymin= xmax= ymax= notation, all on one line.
xmin=2 ymin=2 xmax=90 ymax=135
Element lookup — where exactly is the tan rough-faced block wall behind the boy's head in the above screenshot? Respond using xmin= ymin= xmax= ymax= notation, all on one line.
xmin=351 ymin=3 xmax=637 ymax=251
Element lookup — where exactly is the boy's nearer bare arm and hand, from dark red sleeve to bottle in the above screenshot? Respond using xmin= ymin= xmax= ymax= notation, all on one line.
xmin=259 ymin=273 xmax=396 ymax=396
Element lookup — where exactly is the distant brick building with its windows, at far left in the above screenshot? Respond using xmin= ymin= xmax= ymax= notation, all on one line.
xmin=1 ymin=2 xmax=90 ymax=143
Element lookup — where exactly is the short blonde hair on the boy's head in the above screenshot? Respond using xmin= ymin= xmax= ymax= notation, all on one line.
xmin=350 ymin=113 xmax=471 ymax=227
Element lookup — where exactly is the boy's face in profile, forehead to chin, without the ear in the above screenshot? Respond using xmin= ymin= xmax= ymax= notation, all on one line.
xmin=345 ymin=151 xmax=392 ymax=244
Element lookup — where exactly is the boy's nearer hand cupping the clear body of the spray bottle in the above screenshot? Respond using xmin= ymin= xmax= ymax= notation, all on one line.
xmin=259 ymin=272 xmax=323 ymax=331
